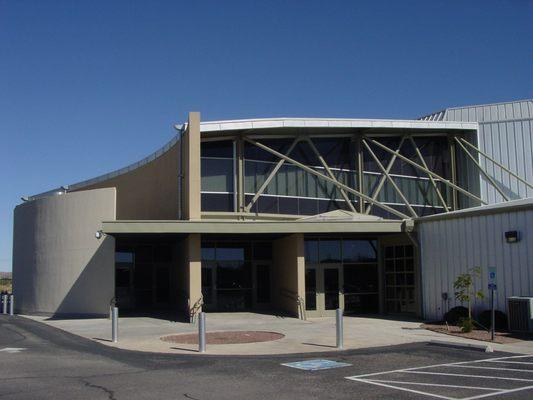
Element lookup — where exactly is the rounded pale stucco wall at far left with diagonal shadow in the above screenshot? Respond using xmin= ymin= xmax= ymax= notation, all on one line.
xmin=13 ymin=188 xmax=116 ymax=315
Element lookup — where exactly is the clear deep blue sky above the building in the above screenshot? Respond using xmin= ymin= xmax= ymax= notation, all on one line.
xmin=0 ymin=0 xmax=533 ymax=271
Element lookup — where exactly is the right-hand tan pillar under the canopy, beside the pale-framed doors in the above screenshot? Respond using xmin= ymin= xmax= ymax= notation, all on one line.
xmin=272 ymin=233 xmax=305 ymax=318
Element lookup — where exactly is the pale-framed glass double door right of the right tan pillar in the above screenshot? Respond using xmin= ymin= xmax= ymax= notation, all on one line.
xmin=305 ymin=264 xmax=344 ymax=317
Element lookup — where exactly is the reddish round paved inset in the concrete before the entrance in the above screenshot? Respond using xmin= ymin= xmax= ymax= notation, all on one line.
xmin=161 ymin=331 xmax=285 ymax=344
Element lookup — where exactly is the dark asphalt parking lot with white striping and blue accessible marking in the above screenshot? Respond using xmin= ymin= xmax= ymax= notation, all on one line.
xmin=0 ymin=316 xmax=533 ymax=400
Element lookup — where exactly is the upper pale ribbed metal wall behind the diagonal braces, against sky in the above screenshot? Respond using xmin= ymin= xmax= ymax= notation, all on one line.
xmin=444 ymin=100 xmax=533 ymax=204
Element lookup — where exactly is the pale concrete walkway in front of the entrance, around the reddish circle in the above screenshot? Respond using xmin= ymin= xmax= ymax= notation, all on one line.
xmin=22 ymin=313 xmax=533 ymax=355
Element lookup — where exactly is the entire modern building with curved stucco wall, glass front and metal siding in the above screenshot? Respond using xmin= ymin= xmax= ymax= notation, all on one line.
xmin=13 ymin=101 xmax=533 ymax=319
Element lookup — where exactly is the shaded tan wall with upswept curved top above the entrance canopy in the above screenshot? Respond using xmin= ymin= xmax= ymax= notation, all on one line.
xmin=72 ymin=141 xmax=180 ymax=220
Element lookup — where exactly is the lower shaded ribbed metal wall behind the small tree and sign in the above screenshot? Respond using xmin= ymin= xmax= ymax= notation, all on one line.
xmin=417 ymin=209 xmax=533 ymax=319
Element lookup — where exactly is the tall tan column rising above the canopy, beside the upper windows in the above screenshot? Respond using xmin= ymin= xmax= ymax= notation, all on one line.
xmin=181 ymin=112 xmax=201 ymax=219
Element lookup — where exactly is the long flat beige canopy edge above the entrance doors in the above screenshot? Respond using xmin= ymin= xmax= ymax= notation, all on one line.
xmin=102 ymin=220 xmax=409 ymax=235
